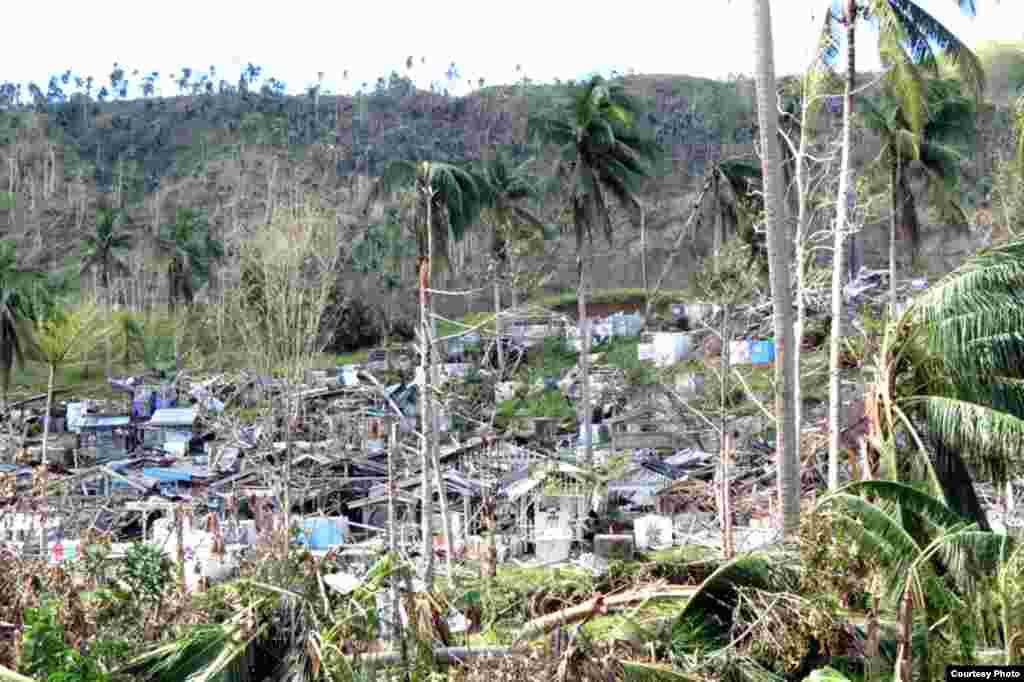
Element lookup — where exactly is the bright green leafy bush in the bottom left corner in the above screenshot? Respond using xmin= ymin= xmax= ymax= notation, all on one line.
xmin=20 ymin=600 xmax=109 ymax=682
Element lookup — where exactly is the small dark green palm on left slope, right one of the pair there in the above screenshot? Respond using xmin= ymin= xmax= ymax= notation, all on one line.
xmin=158 ymin=208 xmax=224 ymax=313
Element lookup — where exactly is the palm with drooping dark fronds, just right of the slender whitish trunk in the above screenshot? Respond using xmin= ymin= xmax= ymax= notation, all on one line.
xmin=859 ymin=79 xmax=976 ymax=305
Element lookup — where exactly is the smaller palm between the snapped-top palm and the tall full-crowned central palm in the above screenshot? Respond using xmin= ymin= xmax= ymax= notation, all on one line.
xmin=479 ymin=152 xmax=549 ymax=370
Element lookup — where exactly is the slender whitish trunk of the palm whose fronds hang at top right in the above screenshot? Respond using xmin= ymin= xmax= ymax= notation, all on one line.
xmin=828 ymin=0 xmax=857 ymax=491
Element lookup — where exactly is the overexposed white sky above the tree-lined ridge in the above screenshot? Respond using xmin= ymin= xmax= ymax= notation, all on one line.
xmin=0 ymin=0 xmax=1024 ymax=94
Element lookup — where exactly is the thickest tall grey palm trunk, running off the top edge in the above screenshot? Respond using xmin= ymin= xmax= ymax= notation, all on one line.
xmin=754 ymin=0 xmax=800 ymax=536
